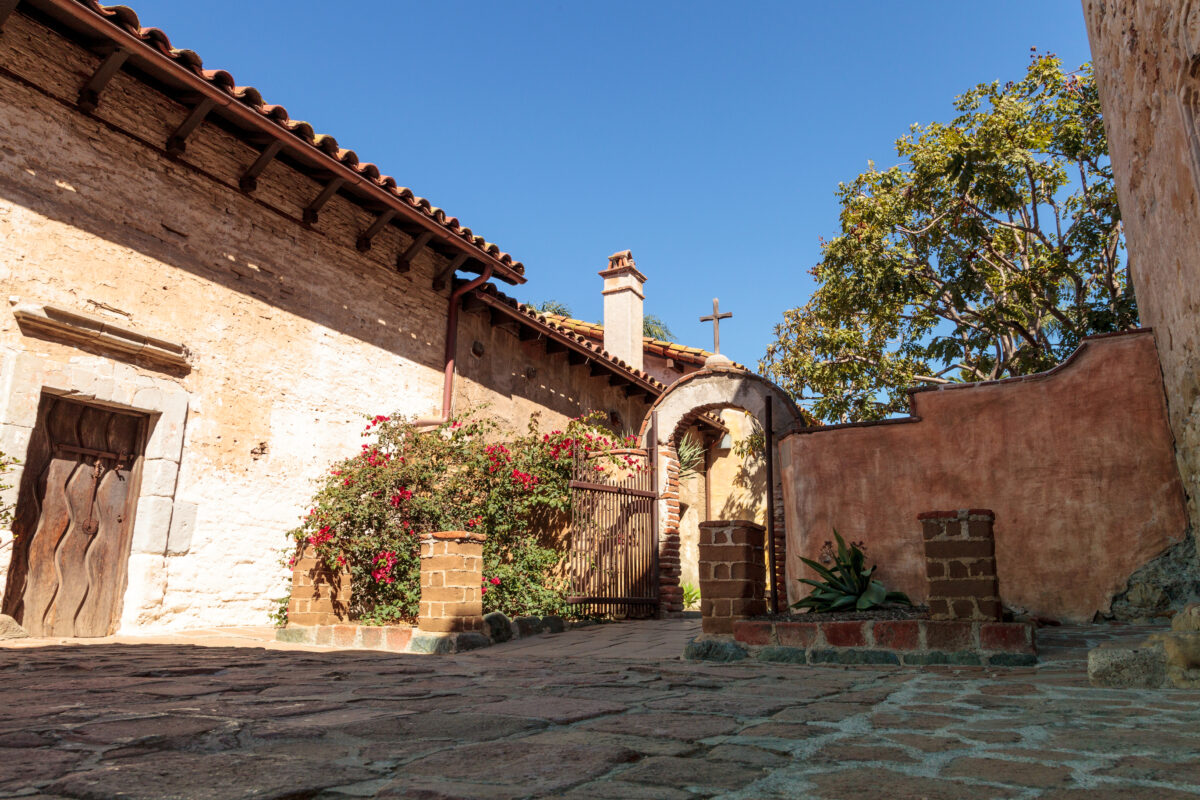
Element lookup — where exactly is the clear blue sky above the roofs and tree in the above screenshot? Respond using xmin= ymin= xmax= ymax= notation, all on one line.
xmin=130 ymin=0 xmax=1090 ymax=366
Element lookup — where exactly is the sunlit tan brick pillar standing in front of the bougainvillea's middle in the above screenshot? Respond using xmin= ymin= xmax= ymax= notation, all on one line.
xmin=416 ymin=530 xmax=485 ymax=633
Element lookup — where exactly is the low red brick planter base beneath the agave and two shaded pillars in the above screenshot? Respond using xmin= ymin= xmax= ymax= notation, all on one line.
xmin=733 ymin=619 xmax=1038 ymax=667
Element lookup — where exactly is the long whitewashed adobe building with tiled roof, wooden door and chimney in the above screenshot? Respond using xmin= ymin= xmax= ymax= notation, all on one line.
xmin=0 ymin=0 xmax=748 ymax=636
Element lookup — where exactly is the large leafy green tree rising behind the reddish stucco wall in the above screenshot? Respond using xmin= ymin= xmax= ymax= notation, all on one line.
xmin=760 ymin=55 xmax=1138 ymax=421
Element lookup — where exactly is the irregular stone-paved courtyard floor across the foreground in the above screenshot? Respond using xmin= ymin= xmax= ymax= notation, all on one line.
xmin=0 ymin=620 xmax=1200 ymax=800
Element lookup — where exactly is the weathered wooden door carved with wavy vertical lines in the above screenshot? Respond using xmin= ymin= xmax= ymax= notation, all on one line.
xmin=4 ymin=395 xmax=145 ymax=637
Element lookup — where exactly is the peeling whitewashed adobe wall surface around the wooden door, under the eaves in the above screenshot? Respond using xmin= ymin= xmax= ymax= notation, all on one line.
xmin=0 ymin=13 xmax=640 ymax=630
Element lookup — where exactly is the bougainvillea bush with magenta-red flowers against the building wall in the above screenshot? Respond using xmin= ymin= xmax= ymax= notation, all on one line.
xmin=290 ymin=416 xmax=630 ymax=624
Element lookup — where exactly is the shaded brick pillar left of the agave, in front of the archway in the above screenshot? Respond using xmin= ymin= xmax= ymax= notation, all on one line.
xmin=700 ymin=519 xmax=767 ymax=633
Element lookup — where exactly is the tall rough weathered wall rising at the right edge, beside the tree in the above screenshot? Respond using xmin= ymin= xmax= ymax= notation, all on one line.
xmin=1082 ymin=0 xmax=1200 ymax=542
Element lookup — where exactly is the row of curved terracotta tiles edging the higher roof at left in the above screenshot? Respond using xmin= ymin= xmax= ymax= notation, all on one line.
xmin=76 ymin=0 xmax=524 ymax=275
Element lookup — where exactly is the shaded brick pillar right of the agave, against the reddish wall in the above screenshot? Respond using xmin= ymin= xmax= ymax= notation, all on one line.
xmin=917 ymin=509 xmax=1001 ymax=620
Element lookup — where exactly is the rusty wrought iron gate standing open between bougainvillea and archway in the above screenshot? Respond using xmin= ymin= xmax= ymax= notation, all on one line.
xmin=568 ymin=419 xmax=659 ymax=616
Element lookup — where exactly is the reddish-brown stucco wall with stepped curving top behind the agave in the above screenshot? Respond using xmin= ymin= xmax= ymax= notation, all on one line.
xmin=780 ymin=331 xmax=1188 ymax=621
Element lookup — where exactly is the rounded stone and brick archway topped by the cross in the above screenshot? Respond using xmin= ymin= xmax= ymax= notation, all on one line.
xmin=638 ymin=367 xmax=804 ymax=613
